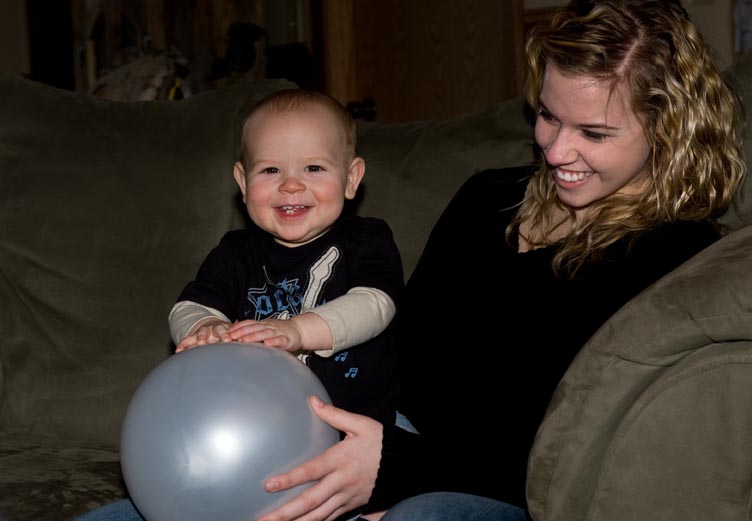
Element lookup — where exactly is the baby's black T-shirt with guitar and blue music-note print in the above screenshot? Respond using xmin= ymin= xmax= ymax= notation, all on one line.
xmin=178 ymin=216 xmax=403 ymax=423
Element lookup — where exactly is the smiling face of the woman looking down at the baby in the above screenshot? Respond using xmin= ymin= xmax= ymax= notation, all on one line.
xmin=535 ymin=65 xmax=650 ymax=215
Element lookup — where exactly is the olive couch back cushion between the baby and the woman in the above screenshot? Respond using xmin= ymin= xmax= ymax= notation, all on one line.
xmin=358 ymin=98 xmax=534 ymax=277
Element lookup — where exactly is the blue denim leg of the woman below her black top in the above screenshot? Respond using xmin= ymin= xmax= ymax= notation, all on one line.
xmin=381 ymin=492 xmax=527 ymax=521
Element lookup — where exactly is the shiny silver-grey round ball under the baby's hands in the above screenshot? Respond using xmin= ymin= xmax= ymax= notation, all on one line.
xmin=120 ymin=343 xmax=339 ymax=521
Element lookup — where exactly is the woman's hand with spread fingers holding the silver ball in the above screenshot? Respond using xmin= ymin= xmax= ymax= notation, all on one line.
xmin=259 ymin=396 xmax=384 ymax=521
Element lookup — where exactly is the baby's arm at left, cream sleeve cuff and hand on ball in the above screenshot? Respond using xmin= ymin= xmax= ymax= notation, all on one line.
xmin=168 ymin=300 xmax=232 ymax=353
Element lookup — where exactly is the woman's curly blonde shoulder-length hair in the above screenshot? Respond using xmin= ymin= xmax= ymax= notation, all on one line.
xmin=507 ymin=0 xmax=745 ymax=274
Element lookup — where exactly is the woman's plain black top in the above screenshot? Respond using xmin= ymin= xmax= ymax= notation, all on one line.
xmin=369 ymin=167 xmax=719 ymax=510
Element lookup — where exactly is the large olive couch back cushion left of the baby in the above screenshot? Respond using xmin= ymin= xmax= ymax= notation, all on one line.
xmin=0 ymin=75 xmax=292 ymax=444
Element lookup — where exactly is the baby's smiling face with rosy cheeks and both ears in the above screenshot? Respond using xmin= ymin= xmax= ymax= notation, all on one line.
xmin=235 ymin=105 xmax=363 ymax=246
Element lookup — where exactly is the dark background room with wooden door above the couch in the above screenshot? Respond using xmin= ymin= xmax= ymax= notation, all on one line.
xmin=0 ymin=0 xmax=744 ymax=122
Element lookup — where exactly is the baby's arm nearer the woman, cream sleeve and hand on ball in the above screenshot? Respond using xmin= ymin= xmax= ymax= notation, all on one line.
xmin=229 ymin=287 xmax=395 ymax=357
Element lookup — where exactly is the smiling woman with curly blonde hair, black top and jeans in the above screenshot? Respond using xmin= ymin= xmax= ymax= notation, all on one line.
xmin=73 ymin=0 xmax=744 ymax=521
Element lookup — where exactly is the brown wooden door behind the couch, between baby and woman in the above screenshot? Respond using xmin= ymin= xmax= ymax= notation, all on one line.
xmin=322 ymin=0 xmax=522 ymax=122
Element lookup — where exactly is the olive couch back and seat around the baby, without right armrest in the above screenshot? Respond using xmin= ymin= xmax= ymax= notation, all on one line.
xmin=0 ymin=70 xmax=533 ymax=521
